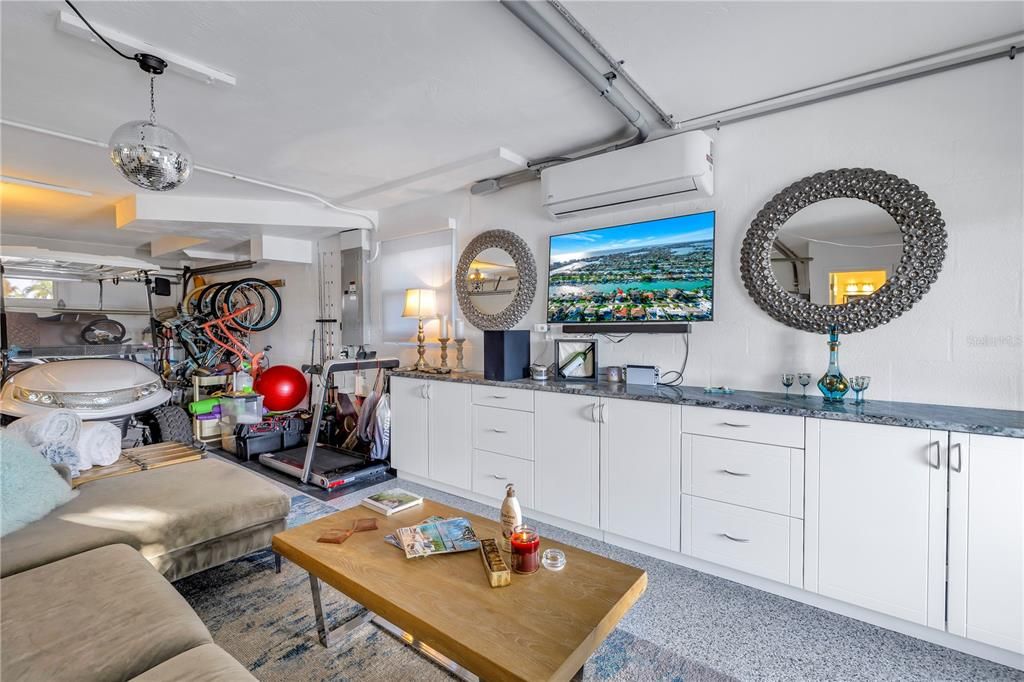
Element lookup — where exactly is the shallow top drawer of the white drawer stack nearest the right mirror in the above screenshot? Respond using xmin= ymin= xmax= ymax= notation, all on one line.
xmin=683 ymin=406 xmax=804 ymax=449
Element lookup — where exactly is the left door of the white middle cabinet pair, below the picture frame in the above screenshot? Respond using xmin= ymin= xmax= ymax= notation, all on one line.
xmin=534 ymin=391 xmax=601 ymax=528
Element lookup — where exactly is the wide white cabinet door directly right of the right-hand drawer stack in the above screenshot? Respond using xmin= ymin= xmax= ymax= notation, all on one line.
xmin=805 ymin=420 xmax=948 ymax=629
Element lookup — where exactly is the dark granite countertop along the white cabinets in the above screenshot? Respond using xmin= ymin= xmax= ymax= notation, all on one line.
xmin=392 ymin=371 xmax=1024 ymax=438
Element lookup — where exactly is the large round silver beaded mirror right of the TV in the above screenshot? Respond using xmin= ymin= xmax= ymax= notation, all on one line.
xmin=740 ymin=168 xmax=946 ymax=334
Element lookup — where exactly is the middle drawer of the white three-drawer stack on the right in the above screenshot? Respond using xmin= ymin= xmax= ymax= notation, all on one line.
xmin=683 ymin=436 xmax=804 ymax=517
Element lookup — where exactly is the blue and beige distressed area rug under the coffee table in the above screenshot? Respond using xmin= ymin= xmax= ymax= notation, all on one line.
xmin=174 ymin=496 xmax=730 ymax=682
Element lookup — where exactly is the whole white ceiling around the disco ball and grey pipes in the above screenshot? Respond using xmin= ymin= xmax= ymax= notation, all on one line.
xmin=0 ymin=0 xmax=1024 ymax=246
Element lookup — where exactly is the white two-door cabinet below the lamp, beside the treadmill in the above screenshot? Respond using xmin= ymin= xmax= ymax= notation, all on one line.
xmin=391 ymin=377 xmax=472 ymax=489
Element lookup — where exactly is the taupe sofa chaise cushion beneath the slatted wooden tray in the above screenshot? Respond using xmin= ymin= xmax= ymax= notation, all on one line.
xmin=0 ymin=459 xmax=291 ymax=576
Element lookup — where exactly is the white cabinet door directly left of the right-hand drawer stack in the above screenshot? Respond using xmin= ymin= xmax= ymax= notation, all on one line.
xmin=600 ymin=398 xmax=681 ymax=551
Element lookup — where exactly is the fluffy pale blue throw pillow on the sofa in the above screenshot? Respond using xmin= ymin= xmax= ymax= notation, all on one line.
xmin=0 ymin=430 xmax=76 ymax=537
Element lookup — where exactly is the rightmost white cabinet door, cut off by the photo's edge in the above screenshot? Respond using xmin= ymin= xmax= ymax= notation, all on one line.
xmin=949 ymin=433 xmax=1024 ymax=653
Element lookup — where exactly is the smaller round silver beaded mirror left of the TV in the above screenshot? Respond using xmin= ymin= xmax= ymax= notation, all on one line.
xmin=455 ymin=229 xmax=537 ymax=331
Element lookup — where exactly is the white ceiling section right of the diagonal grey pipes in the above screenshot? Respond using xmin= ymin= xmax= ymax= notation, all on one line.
xmin=564 ymin=0 xmax=1024 ymax=121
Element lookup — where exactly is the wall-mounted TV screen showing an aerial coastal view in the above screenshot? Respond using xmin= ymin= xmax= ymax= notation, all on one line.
xmin=548 ymin=211 xmax=715 ymax=323
